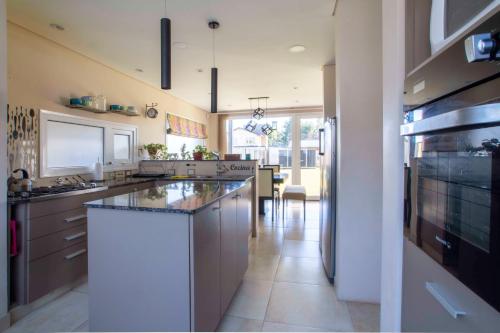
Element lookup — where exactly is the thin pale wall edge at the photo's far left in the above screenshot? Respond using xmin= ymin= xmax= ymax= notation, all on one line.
xmin=0 ymin=0 xmax=8 ymax=331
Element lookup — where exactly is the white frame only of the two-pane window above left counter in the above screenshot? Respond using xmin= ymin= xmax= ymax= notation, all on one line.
xmin=39 ymin=110 xmax=139 ymax=178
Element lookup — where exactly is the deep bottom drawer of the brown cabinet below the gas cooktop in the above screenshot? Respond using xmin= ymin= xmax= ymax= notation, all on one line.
xmin=28 ymin=242 xmax=87 ymax=303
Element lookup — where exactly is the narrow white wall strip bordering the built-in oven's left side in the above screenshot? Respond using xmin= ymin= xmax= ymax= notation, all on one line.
xmin=380 ymin=0 xmax=405 ymax=331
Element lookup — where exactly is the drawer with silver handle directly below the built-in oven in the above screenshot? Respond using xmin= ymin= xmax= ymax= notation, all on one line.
xmin=401 ymin=239 xmax=500 ymax=332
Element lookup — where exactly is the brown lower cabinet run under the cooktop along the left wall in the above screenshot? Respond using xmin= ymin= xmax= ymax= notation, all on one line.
xmin=10 ymin=182 xmax=154 ymax=307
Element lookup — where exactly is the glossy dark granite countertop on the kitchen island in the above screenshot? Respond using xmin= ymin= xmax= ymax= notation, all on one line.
xmin=85 ymin=177 xmax=251 ymax=214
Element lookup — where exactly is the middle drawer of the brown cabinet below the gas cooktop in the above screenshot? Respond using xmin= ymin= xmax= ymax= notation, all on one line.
xmin=28 ymin=224 xmax=87 ymax=261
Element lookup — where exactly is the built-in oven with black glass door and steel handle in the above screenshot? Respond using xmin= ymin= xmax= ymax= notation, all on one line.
xmin=401 ymin=8 xmax=500 ymax=312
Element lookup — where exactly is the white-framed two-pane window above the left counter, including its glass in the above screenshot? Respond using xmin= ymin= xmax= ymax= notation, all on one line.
xmin=40 ymin=110 xmax=137 ymax=177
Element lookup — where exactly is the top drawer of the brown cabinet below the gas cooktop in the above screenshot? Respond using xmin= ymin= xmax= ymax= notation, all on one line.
xmin=28 ymin=206 xmax=87 ymax=240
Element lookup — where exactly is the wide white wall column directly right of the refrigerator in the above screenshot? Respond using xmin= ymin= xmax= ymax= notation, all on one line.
xmin=335 ymin=0 xmax=382 ymax=303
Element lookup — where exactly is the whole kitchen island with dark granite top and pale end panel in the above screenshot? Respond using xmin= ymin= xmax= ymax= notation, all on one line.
xmin=86 ymin=178 xmax=252 ymax=331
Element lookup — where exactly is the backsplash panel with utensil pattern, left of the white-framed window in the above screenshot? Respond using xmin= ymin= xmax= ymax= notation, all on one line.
xmin=7 ymin=105 xmax=40 ymax=179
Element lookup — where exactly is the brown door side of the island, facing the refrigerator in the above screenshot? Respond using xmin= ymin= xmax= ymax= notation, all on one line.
xmin=193 ymin=184 xmax=252 ymax=332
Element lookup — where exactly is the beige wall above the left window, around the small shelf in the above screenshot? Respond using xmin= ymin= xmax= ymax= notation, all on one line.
xmin=7 ymin=22 xmax=217 ymax=147
